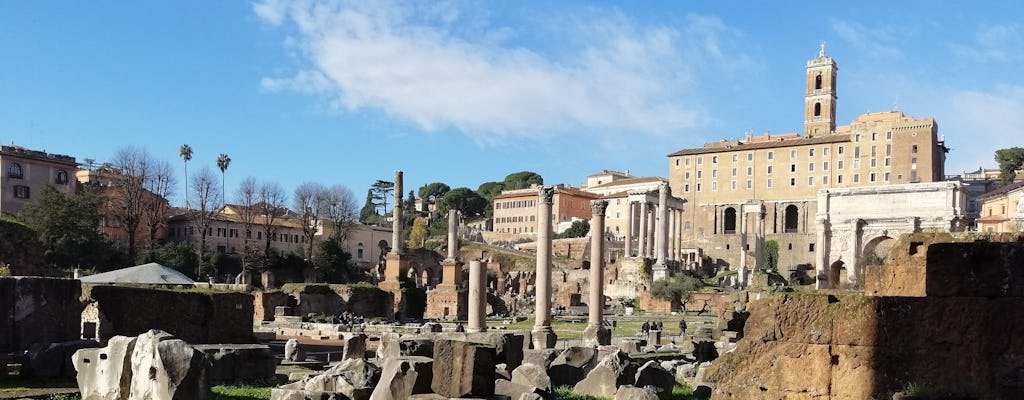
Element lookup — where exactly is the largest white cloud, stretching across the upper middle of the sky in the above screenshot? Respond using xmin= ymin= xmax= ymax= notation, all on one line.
xmin=254 ymin=0 xmax=749 ymax=142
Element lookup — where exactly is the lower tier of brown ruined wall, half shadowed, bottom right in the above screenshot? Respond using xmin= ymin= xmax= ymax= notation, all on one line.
xmin=705 ymin=295 xmax=1024 ymax=400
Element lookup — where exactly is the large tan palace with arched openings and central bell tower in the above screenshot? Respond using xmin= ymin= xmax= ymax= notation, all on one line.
xmin=669 ymin=49 xmax=947 ymax=276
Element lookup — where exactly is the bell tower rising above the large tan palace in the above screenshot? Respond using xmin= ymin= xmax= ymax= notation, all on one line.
xmin=804 ymin=43 xmax=839 ymax=137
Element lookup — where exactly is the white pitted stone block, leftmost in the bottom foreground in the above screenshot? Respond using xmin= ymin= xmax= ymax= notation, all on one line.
xmin=72 ymin=337 xmax=136 ymax=400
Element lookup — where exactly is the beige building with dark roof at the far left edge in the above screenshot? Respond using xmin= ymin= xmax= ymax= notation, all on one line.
xmin=0 ymin=145 xmax=78 ymax=215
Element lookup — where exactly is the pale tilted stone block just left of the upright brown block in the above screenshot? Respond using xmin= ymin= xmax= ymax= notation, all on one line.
xmin=370 ymin=357 xmax=433 ymax=400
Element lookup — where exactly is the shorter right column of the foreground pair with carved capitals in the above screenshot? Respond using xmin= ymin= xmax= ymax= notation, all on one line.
xmin=583 ymin=201 xmax=611 ymax=346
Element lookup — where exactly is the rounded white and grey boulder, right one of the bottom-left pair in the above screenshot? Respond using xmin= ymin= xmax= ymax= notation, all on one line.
xmin=131 ymin=330 xmax=210 ymax=400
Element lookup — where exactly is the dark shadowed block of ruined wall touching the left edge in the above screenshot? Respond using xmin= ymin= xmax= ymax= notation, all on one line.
xmin=0 ymin=276 xmax=82 ymax=353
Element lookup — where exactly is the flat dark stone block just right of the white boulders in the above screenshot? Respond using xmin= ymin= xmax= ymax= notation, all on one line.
xmin=194 ymin=345 xmax=278 ymax=385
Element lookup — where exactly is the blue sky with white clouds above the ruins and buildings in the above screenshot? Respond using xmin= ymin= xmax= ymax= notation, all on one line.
xmin=0 ymin=0 xmax=1024 ymax=206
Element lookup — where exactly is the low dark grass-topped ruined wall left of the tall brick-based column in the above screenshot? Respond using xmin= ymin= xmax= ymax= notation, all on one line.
xmin=282 ymin=284 xmax=393 ymax=317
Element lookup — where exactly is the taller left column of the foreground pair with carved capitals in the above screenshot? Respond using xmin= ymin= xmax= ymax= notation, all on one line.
xmin=532 ymin=186 xmax=558 ymax=349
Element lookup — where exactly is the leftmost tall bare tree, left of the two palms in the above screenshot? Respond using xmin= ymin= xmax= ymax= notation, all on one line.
xmin=112 ymin=146 xmax=153 ymax=262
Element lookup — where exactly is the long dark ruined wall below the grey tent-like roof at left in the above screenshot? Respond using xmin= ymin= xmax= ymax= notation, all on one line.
xmin=82 ymin=285 xmax=254 ymax=344
